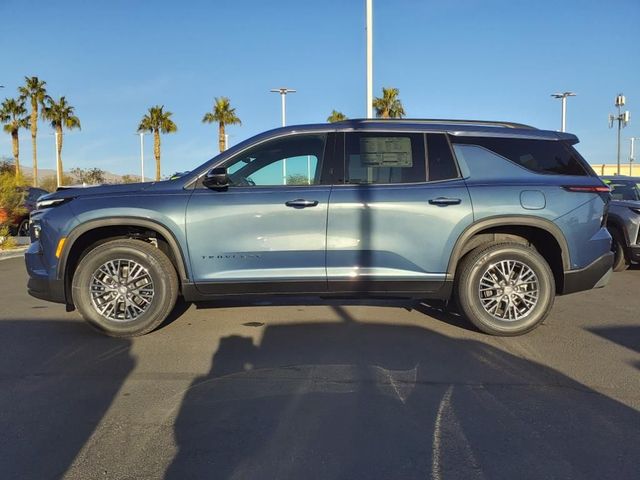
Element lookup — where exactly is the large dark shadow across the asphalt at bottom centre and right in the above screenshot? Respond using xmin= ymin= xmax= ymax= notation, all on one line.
xmin=166 ymin=306 xmax=640 ymax=480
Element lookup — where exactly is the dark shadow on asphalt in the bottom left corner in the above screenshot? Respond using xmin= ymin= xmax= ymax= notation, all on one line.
xmin=0 ymin=319 xmax=135 ymax=479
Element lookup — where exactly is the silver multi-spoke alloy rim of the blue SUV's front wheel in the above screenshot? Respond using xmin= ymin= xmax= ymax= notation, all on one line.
xmin=89 ymin=259 xmax=155 ymax=322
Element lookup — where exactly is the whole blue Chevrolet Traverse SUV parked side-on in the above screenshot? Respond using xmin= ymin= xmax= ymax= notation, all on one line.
xmin=26 ymin=120 xmax=612 ymax=337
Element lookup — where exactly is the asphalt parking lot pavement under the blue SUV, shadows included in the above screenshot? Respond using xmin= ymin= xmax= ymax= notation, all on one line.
xmin=0 ymin=258 xmax=640 ymax=480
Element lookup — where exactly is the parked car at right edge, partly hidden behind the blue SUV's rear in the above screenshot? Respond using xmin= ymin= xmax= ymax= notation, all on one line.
xmin=602 ymin=176 xmax=640 ymax=272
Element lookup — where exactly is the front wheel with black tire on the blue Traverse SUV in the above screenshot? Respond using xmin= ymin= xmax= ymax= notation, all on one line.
xmin=72 ymin=239 xmax=178 ymax=337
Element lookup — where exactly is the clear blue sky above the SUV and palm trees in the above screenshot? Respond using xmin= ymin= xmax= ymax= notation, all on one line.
xmin=0 ymin=0 xmax=640 ymax=174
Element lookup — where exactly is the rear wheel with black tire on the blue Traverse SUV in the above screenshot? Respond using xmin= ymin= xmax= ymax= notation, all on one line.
xmin=456 ymin=243 xmax=556 ymax=336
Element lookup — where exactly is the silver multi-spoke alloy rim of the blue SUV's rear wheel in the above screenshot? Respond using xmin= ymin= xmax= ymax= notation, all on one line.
xmin=478 ymin=260 xmax=540 ymax=322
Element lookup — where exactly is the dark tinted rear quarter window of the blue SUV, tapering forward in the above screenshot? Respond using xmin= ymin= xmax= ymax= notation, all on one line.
xmin=451 ymin=136 xmax=592 ymax=176
